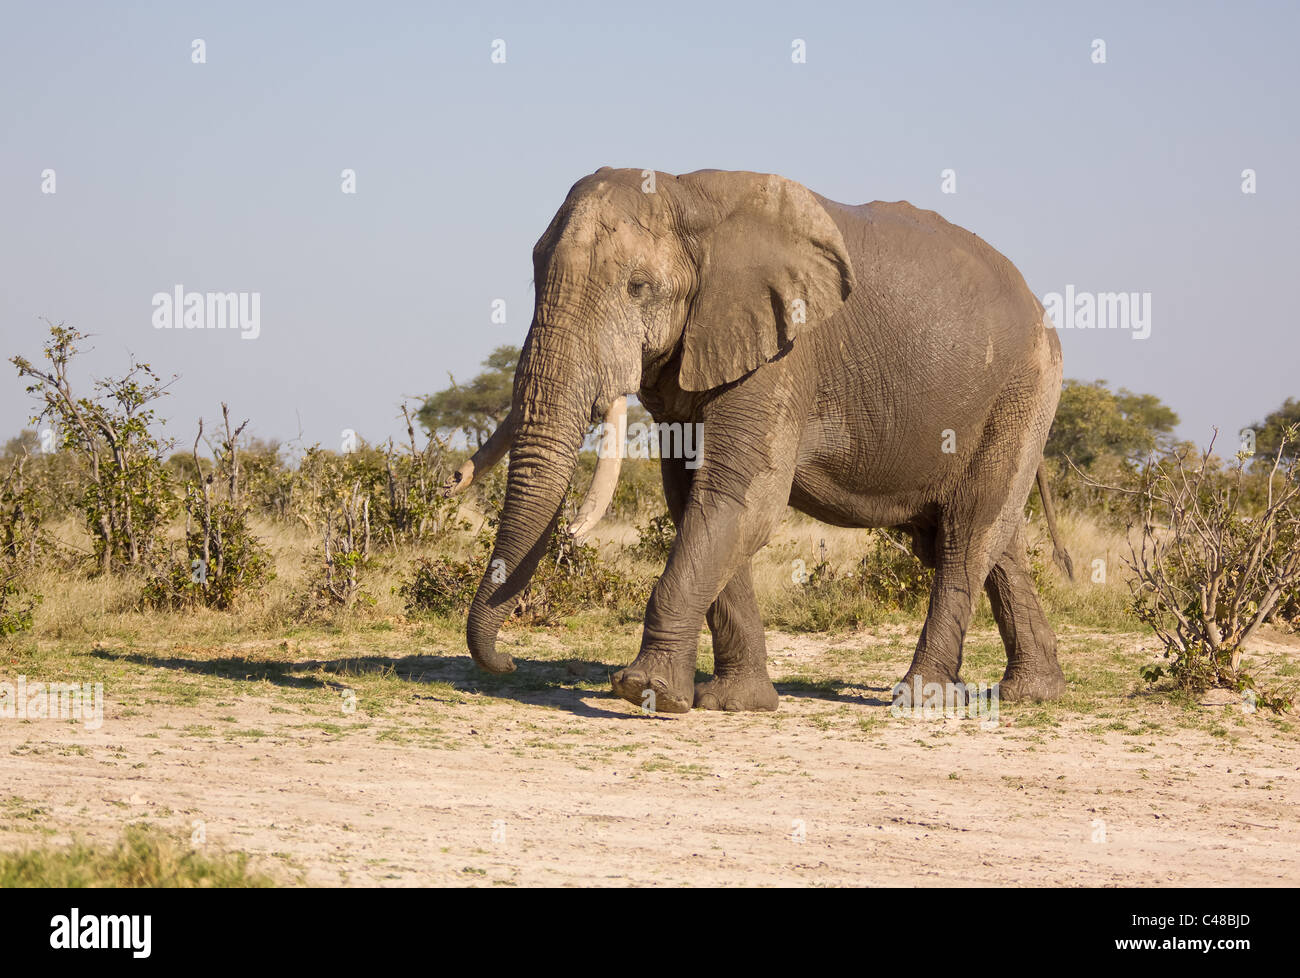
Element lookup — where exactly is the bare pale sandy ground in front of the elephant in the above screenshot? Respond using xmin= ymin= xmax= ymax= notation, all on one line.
xmin=0 ymin=633 xmax=1300 ymax=886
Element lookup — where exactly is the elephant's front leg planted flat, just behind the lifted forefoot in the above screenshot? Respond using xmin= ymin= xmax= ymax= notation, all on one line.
xmin=696 ymin=563 xmax=777 ymax=710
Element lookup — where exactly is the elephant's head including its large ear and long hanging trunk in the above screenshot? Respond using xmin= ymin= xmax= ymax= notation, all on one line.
xmin=467 ymin=168 xmax=853 ymax=672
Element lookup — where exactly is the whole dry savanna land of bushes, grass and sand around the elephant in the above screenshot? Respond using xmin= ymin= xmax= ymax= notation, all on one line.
xmin=0 ymin=325 xmax=1300 ymax=886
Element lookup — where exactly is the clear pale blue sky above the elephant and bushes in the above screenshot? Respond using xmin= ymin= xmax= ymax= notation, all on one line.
xmin=0 ymin=0 xmax=1300 ymax=445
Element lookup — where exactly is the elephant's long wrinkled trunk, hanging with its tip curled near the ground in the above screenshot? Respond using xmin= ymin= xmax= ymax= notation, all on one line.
xmin=465 ymin=329 xmax=595 ymax=672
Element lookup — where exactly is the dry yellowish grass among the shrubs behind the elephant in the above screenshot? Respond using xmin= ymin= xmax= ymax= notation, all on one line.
xmin=10 ymin=512 xmax=1296 ymax=712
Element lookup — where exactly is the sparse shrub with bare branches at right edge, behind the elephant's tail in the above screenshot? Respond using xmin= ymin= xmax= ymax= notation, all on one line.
xmin=1127 ymin=428 xmax=1300 ymax=709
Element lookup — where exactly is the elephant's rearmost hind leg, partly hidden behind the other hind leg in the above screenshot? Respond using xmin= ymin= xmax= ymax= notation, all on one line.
xmin=984 ymin=531 xmax=1065 ymax=701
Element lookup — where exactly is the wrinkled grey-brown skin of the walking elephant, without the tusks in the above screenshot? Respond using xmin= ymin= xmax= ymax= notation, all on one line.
xmin=467 ymin=168 xmax=1065 ymax=713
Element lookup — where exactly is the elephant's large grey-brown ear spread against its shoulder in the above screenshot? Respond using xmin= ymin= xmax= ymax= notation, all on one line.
xmin=679 ymin=170 xmax=854 ymax=390
